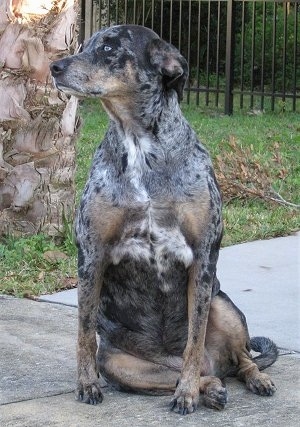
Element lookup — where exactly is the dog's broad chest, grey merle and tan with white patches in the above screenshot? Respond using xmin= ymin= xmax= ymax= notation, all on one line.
xmin=87 ymin=133 xmax=208 ymax=291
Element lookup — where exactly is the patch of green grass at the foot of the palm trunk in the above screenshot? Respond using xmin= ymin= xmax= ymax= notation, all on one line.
xmin=0 ymin=234 xmax=76 ymax=297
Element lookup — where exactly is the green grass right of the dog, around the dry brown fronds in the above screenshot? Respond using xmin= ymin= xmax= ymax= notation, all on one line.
xmin=183 ymin=102 xmax=300 ymax=246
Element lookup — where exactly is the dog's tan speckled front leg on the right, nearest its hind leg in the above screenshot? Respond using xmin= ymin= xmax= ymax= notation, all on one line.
xmin=171 ymin=262 xmax=213 ymax=415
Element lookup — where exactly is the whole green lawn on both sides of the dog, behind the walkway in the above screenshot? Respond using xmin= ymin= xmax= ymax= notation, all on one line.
xmin=0 ymin=102 xmax=300 ymax=297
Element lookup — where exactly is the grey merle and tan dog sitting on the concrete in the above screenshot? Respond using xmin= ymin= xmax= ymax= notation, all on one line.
xmin=50 ymin=25 xmax=278 ymax=415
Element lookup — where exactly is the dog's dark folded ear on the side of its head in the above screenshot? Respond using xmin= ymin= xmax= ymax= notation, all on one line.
xmin=148 ymin=39 xmax=188 ymax=101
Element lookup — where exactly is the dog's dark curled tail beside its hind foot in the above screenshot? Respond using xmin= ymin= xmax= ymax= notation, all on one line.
xmin=250 ymin=337 xmax=278 ymax=371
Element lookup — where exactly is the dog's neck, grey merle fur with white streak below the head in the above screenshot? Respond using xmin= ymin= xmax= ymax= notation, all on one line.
xmin=102 ymin=92 xmax=191 ymax=186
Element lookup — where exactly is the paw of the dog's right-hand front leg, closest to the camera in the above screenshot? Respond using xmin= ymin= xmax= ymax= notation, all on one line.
xmin=170 ymin=382 xmax=199 ymax=415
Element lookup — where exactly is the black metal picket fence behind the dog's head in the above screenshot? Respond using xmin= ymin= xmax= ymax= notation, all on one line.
xmin=81 ymin=0 xmax=300 ymax=114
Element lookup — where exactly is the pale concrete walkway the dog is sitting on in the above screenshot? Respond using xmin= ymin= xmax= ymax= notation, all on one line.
xmin=0 ymin=234 xmax=300 ymax=427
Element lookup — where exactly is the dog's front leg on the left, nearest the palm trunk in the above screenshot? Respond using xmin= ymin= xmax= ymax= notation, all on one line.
xmin=76 ymin=244 xmax=103 ymax=404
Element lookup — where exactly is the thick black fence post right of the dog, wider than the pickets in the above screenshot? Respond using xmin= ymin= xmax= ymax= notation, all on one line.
xmin=225 ymin=0 xmax=235 ymax=115
